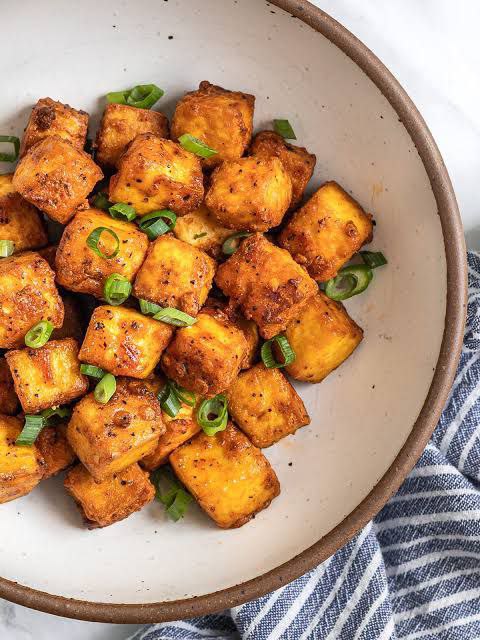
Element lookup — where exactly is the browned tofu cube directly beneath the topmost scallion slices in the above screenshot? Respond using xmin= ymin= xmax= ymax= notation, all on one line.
xmin=95 ymin=104 xmax=169 ymax=168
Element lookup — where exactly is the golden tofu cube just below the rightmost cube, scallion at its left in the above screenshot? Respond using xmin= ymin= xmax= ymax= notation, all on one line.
xmin=285 ymin=291 xmax=363 ymax=382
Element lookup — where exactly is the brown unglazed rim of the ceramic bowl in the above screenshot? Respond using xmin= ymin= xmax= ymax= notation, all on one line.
xmin=0 ymin=0 xmax=467 ymax=624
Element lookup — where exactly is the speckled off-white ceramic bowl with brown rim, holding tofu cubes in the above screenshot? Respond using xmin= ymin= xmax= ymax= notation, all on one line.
xmin=0 ymin=0 xmax=466 ymax=622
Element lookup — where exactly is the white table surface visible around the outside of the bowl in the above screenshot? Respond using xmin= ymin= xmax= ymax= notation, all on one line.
xmin=0 ymin=0 xmax=480 ymax=640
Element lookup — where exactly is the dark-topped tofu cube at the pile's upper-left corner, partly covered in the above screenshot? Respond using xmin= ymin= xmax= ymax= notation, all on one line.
xmin=20 ymin=98 xmax=88 ymax=156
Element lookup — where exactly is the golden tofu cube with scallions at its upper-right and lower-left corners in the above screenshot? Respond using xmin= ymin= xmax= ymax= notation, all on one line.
xmin=79 ymin=305 xmax=173 ymax=378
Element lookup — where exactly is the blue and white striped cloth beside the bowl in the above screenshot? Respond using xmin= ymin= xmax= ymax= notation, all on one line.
xmin=130 ymin=253 xmax=480 ymax=640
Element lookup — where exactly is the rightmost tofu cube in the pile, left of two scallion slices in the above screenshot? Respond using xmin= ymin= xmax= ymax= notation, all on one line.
xmin=279 ymin=182 xmax=373 ymax=282
